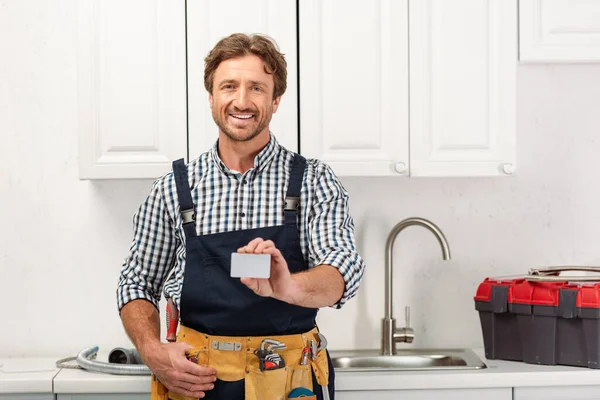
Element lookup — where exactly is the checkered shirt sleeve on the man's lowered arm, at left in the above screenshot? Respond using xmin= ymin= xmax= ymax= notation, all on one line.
xmin=117 ymin=179 xmax=178 ymax=311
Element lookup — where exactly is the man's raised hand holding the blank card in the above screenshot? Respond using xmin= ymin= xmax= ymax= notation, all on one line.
xmin=238 ymin=238 xmax=297 ymax=303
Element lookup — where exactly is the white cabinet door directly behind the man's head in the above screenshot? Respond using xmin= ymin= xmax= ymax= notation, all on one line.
xmin=187 ymin=0 xmax=298 ymax=159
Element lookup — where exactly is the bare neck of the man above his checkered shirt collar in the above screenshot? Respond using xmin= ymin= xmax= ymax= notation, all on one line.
xmin=218 ymin=130 xmax=270 ymax=174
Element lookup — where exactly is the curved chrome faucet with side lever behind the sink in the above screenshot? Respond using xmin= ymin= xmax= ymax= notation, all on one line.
xmin=381 ymin=218 xmax=450 ymax=356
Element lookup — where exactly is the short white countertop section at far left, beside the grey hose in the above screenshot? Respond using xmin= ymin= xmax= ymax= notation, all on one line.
xmin=0 ymin=358 xmax=59 ymax=393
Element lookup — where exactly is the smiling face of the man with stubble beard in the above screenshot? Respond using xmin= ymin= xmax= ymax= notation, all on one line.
xmin=208 ymin=55 xmax=281 ymax=142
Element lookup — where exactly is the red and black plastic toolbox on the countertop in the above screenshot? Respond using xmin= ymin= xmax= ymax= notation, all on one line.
xmin=475 ymin=267 xmax=600 ymax=369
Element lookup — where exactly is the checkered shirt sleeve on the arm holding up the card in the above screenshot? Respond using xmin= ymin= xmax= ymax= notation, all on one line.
xmin=308 ymin=166 xmax=365 ymax=308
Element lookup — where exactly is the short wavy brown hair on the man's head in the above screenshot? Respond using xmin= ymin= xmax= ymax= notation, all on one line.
xmin=204 ymin=33 xmax=287 ymax=99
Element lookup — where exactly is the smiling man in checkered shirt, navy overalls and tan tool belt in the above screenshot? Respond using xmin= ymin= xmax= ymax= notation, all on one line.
xmin=117 ymin=34 xmax=364 ymax=400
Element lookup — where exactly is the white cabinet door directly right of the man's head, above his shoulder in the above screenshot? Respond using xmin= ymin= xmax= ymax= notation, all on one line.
xmin=299 ymin=0 xmax=408 ymax=176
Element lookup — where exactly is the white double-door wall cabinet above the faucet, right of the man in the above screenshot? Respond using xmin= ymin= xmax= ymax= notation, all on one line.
xmin=299 ymin=0 xmax=517 ymax=176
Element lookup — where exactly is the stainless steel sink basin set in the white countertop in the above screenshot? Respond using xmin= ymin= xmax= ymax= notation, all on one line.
xmin=331 ymin=349 xmax=487 ymax=371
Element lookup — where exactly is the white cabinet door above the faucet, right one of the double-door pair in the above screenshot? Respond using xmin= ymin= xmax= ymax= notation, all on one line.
xmin=409 ymin=0 xmax=517 ymax=176
